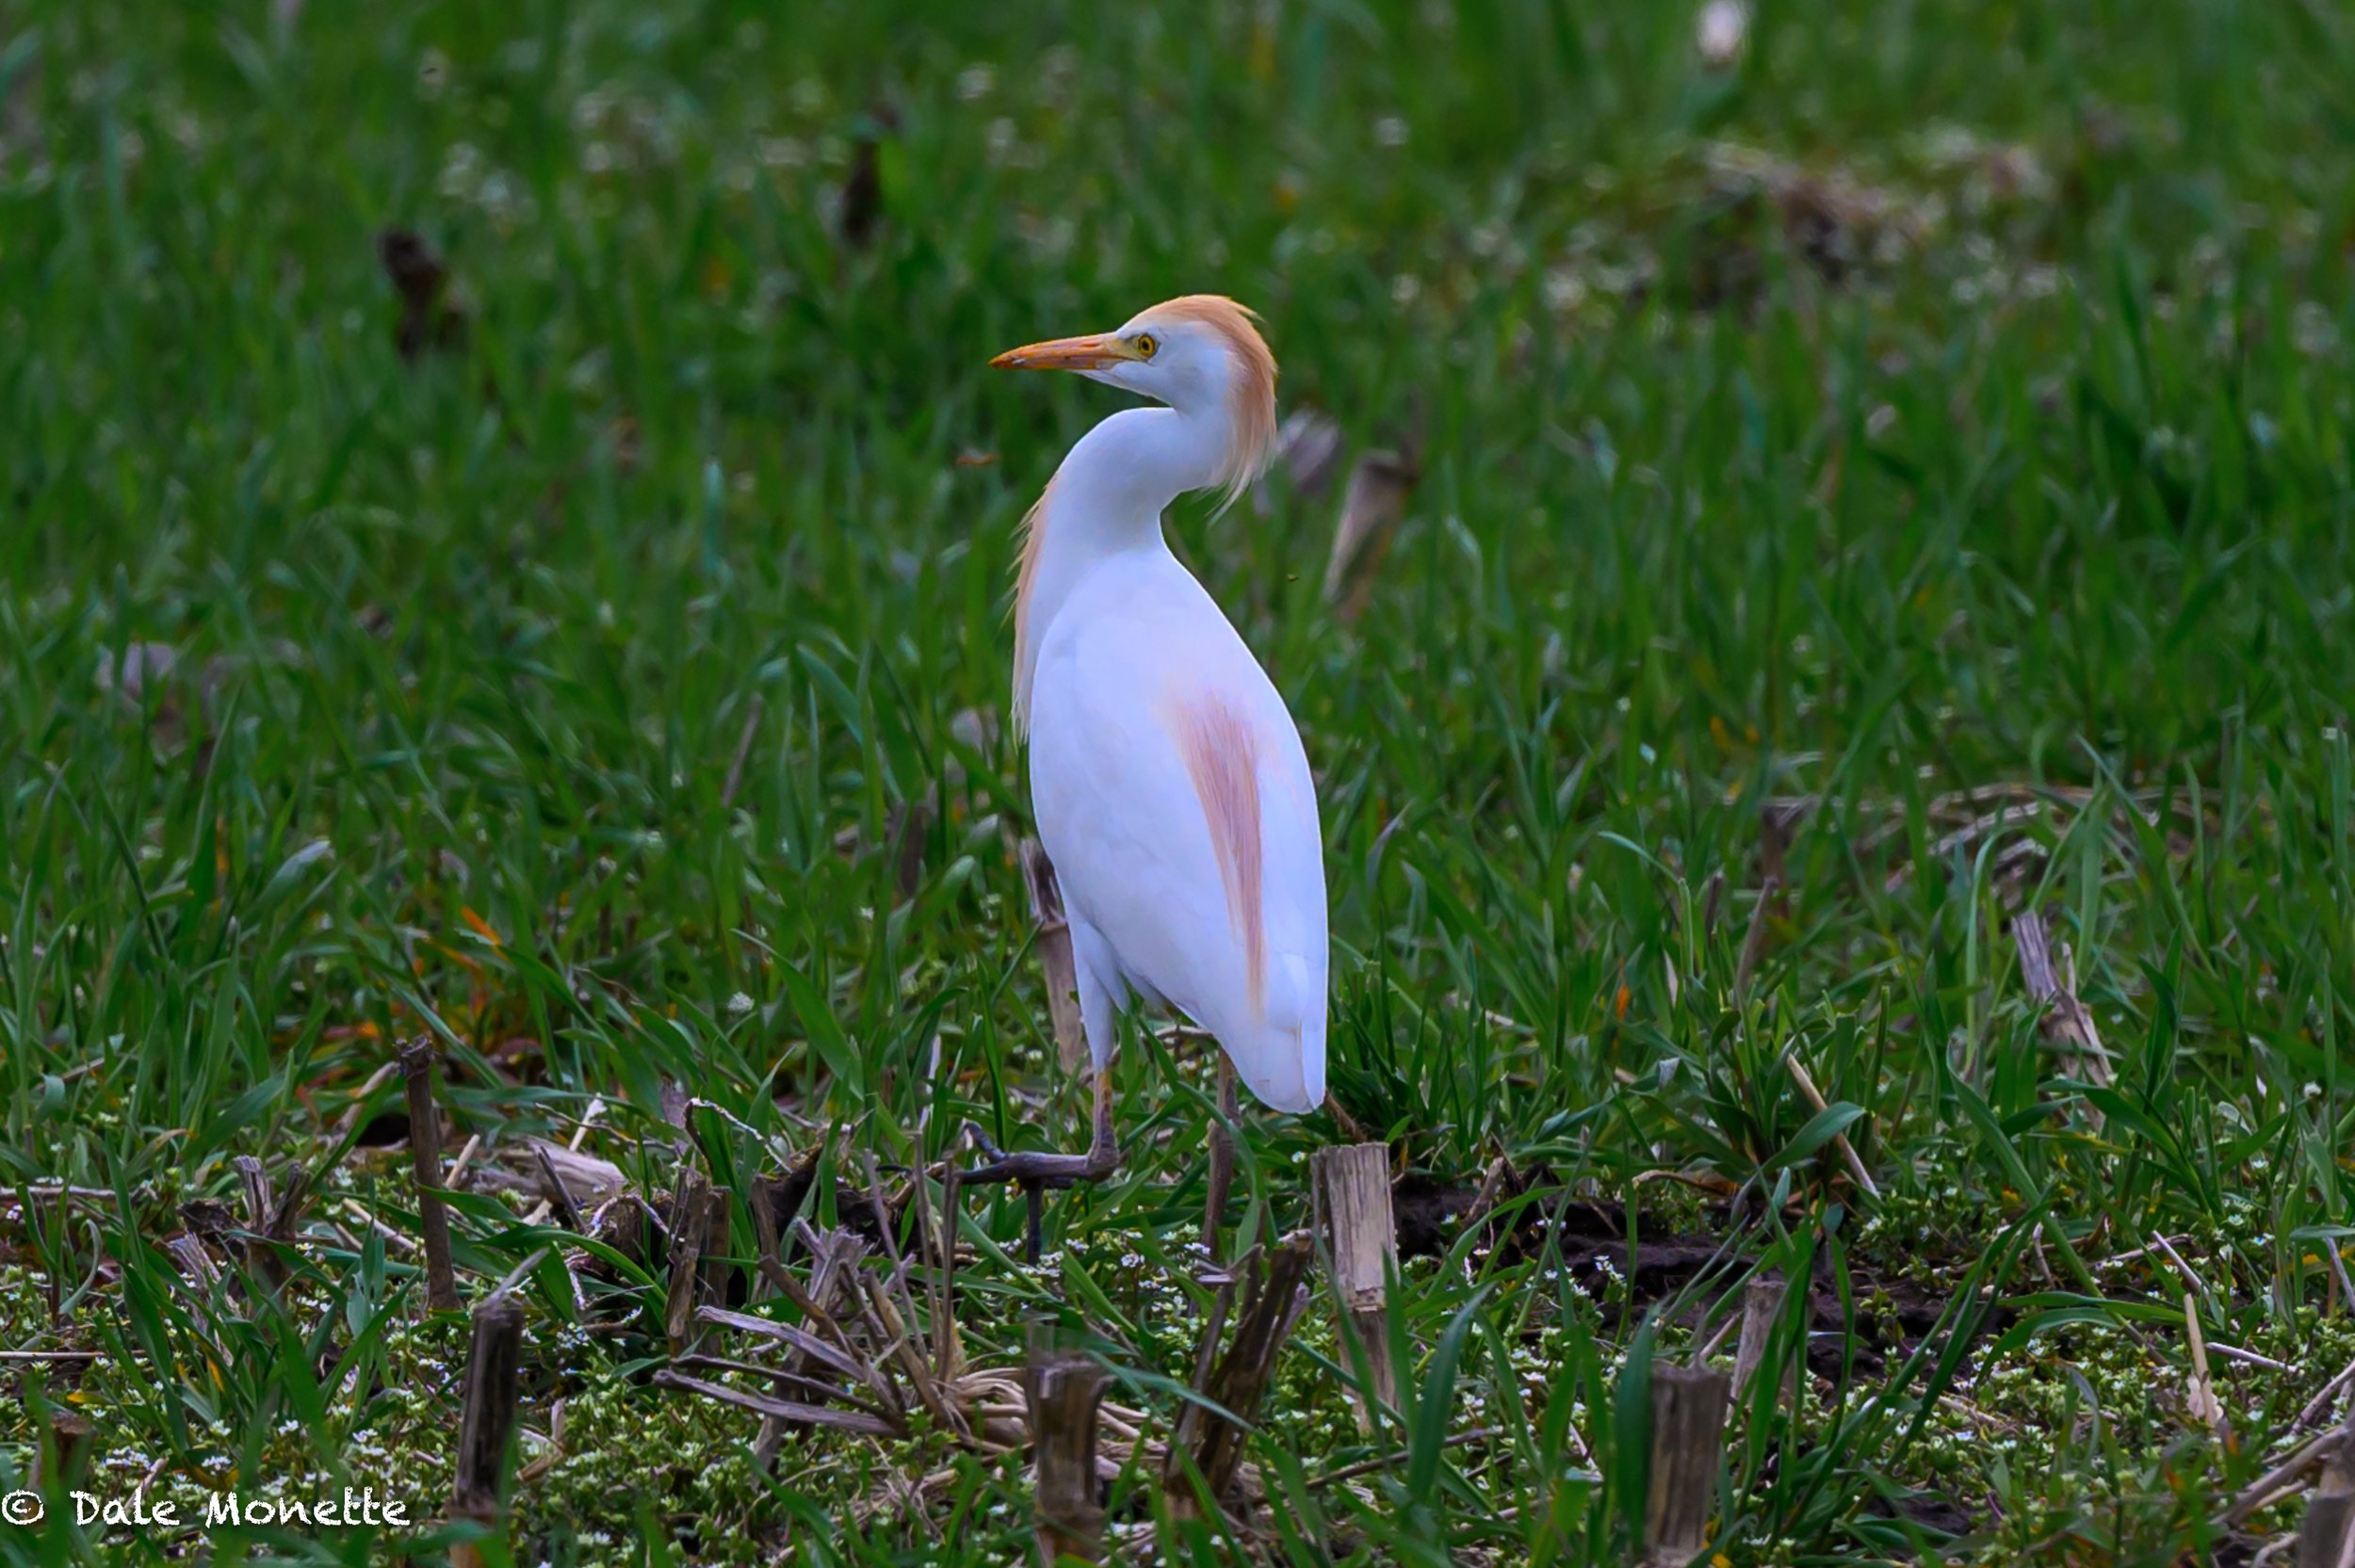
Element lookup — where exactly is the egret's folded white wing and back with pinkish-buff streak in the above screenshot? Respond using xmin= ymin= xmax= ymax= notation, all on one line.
xmin=1030 ymin=549 xmax=1326 ymax=1111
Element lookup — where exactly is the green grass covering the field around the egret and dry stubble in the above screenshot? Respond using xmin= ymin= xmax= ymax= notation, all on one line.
xmin=0 ymin=0 xmax=2355 ymax=1566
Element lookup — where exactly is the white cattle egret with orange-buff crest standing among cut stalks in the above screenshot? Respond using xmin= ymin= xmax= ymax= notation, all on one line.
xmin=975 ymin=295 xmax=1326 ymax=1191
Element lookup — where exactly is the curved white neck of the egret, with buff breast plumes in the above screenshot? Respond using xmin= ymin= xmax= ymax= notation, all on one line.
xmin=1015 ymin=408 xmax=1232 ymax=714
